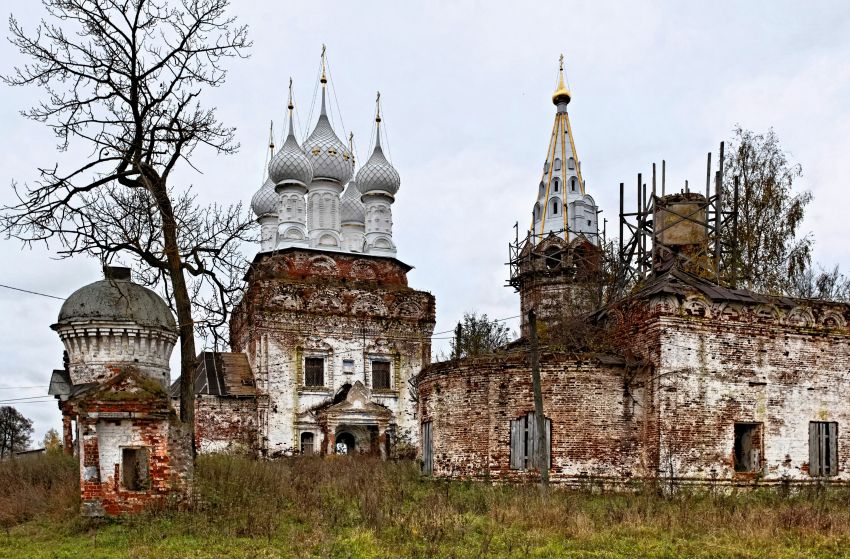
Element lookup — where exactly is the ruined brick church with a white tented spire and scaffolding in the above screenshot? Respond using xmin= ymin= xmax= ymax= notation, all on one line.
xmin=415 ymin=59 xmax=850 ymax=485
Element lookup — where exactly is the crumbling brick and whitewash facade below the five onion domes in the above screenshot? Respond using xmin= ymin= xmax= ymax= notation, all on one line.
xmin=231 ymin=249 xmax=435 ymax=456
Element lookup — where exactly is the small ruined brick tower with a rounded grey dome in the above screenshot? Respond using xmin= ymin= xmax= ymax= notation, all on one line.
xmin=49 ymin=267 xmax=192 ymax=516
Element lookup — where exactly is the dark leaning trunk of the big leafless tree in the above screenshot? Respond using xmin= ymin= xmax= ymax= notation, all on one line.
xmin=152 ymin=180 xmax=197 ymax=454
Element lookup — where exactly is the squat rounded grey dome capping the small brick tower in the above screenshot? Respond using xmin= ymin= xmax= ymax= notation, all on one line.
xmin=54 ymin=266 xmax=177 ymax=333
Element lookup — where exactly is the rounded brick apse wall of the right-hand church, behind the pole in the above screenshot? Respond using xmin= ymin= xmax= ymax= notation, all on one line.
xmin=417 ymin=349 xmax=646 ymax=483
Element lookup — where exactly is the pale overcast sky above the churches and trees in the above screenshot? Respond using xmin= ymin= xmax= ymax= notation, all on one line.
xmin=0 ymin=0 xmax=850 ymax=446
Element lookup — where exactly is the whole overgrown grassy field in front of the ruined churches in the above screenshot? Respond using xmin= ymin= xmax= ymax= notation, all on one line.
xmin=0 ymin=455 xmax=850 ymax=559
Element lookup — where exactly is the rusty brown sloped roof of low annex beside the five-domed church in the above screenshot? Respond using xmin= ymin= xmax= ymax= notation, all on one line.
xmin=169 ymin=351 xmax=257 ymax=398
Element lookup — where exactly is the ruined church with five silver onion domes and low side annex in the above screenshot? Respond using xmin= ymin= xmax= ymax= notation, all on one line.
xmin=183 ymin=58 xmax=435 ymax=457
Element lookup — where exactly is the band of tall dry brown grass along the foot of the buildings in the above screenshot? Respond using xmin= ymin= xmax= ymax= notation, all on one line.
xmin=0 ymin=455 xmax=850 ymax=557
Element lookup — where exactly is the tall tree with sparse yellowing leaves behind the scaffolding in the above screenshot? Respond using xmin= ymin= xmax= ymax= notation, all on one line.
xmin=723 ymin=126 xmax=812 ymax=293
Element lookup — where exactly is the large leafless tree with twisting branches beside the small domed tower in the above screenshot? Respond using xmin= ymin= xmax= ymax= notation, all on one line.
xmin=2 ymin=0 xmax=250 ymax=434
